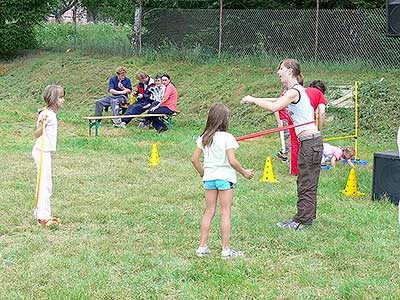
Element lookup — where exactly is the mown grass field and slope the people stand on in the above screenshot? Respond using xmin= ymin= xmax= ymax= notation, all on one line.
xmin=0 ymin=53 xmax=400 ymax=299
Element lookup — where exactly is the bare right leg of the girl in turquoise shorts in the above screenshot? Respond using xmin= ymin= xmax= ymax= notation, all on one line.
xmin=219 ymin=189 xmax=234 ymax=250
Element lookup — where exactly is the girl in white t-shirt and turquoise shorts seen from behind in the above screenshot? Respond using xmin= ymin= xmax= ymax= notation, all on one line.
xmin=192 ymin=103 xmax=254 ymax=259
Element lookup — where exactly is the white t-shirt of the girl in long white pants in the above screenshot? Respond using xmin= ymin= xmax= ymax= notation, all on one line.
xmin=34 ymin=109 xmax=57 ymax=152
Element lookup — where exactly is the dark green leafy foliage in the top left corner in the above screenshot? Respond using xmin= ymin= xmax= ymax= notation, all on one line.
xmin=0 ymin=0 xmax=57 ymax=54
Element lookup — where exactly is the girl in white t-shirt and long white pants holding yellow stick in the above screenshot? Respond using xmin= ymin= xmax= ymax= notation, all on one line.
xmin=32 ymin=85 xmax=65 ymax=225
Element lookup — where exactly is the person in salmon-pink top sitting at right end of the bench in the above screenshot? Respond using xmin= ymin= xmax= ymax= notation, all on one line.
xmin=149 ymin=74 xmax=178 ymax=133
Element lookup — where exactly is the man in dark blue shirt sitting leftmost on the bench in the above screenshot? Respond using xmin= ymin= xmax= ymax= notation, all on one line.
xmin=95 ymin=67 xmax=132 ymax=127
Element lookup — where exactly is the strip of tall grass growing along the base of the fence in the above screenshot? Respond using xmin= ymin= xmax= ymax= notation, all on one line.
xmin=35 ymin=23 xmax=395 ymax=73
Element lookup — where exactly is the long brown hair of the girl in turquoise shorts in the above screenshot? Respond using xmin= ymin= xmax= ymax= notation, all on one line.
xmin=201 ymin=103 xmax=230 ymax=147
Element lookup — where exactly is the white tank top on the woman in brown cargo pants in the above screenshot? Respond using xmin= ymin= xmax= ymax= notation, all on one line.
xmin=287 ymin=84 xmax=318 ymax=136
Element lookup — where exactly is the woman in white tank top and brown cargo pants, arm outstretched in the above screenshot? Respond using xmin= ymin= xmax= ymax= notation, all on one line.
xmin=241 ymin=59 xmax=323 ymax=230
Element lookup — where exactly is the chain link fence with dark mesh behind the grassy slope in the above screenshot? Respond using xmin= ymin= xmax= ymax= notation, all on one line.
xmin=142 ymin=9 xmax=400 ymax=67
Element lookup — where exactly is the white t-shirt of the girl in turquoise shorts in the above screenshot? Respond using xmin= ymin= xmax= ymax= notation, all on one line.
xmin=196 ymin=131 xmax=239 ymax=183
